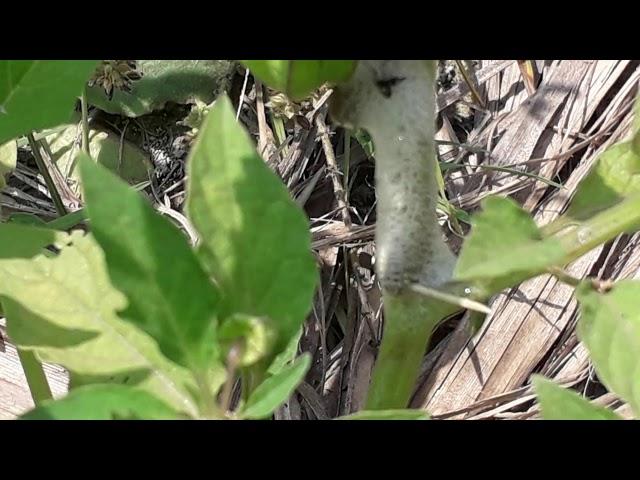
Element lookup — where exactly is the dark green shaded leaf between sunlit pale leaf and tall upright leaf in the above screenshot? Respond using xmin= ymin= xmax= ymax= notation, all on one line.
xmin=79 ymin=154 xmax=218 ymax=373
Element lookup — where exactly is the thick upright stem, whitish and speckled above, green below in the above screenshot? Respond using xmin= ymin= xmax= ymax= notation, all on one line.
xmin=331 ymin=60 xmax=460 ymax=409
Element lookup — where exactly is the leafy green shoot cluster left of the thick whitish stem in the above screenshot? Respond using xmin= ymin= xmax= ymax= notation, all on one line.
xmin=0 ymin=95 xmax=316 ymax=418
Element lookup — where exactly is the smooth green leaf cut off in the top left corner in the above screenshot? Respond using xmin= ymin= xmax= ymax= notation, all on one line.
xmin=0 ymin=60 xmax=98 ymax=144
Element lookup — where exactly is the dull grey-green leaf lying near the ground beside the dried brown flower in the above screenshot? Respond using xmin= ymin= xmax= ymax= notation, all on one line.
xmin=87 ymin=60 xmax=236 ymax=117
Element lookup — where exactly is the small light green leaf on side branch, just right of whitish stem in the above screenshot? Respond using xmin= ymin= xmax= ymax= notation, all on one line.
xmin=454 ymin=197 xmax=564 ymax=292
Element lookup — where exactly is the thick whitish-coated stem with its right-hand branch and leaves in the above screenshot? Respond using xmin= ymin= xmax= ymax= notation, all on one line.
xmin=320 ymin=61 xmax=640 ymax=414
